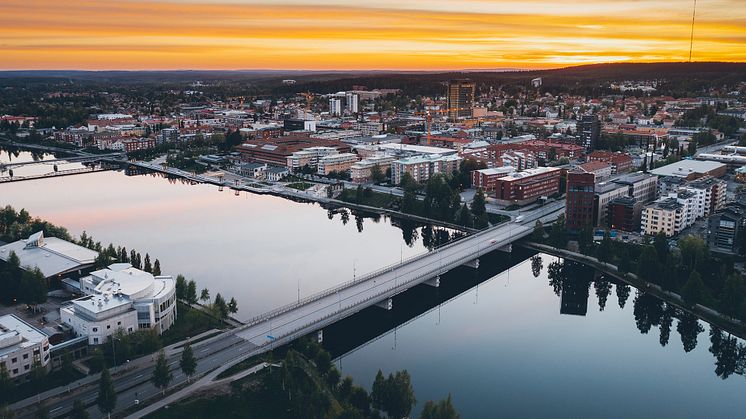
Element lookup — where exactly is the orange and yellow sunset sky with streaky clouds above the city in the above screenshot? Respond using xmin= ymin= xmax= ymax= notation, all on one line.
xmin=0 ymin=0 xmax=746 ymax=70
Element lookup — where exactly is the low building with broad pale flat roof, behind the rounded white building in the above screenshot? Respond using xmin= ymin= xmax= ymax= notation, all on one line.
xmin=0 ymin=231 xmax=98 ymax=278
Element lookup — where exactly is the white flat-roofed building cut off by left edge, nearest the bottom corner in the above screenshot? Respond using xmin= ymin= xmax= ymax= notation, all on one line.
xmin=0 ymin=314 xmax=49 ymax=378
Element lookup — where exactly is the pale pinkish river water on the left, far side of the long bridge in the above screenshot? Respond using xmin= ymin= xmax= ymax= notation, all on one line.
xmin=0 ymin=149 xmax=436 ymax=318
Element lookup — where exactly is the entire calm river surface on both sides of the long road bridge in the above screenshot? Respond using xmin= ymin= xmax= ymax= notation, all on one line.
xmin=0 ymin=148 xmax=746 ymax=418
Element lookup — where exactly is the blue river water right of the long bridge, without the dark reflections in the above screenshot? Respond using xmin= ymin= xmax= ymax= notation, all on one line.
xmin=326 ymin=255 xmax=746 ymax=418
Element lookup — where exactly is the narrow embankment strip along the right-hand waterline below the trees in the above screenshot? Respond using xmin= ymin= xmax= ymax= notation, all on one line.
xmin=517 ymin=242 xmax=746 ymax=339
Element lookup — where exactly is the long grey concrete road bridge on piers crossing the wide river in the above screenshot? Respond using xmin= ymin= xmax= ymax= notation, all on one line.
xmin=234 ymin=201 xmax=564 ymax=352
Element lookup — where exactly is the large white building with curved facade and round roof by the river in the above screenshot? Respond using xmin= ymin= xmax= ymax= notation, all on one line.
xmin=60 ymin=263 xmax=177 ymax=345
